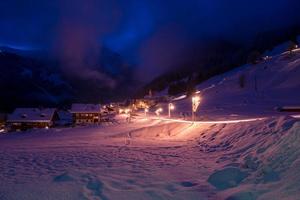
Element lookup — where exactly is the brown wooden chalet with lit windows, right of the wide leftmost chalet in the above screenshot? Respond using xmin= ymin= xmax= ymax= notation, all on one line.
xmin=70 ymin=104 xmax=101 ymax=125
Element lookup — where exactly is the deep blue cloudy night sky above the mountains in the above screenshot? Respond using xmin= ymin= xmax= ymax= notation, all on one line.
xmin=0 ymin=0 xmax=300 ymax=80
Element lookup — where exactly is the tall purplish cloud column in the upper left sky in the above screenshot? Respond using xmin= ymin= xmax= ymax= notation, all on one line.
xmin=52 ymin=0 xmax=117 ymax=88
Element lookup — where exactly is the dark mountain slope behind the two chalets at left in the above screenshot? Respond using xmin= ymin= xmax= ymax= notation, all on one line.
xmin=0 ymin=48 xmax=135 ymax=111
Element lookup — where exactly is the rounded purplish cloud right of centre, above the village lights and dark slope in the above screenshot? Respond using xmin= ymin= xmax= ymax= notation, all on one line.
xmin=136 ymin=24 xmax=190 ymax=81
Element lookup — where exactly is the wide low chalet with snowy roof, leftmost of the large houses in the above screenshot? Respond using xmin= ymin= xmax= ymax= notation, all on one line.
xmin=6 ymin=108 xmax=58 ymax=131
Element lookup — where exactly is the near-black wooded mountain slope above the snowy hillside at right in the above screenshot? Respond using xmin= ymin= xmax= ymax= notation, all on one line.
xmin=136 ymin=25 xmax=300 ymax=97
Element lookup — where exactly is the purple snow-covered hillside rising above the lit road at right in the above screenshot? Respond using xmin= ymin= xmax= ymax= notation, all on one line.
xmin=156 ymin=49 xmax=300 ymax=120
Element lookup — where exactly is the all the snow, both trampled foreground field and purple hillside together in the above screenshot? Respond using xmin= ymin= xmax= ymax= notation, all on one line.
xmin=0 ymin=43 xmax=300 ymax=200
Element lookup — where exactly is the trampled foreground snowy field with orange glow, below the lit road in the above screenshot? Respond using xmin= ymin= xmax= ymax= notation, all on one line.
xmin=0 ymin=117 xmax=300 ymax=200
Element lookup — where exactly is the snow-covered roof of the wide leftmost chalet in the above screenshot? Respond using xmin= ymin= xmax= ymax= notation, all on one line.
xmin=7 ymin=108 xmax=56 ymax=122
